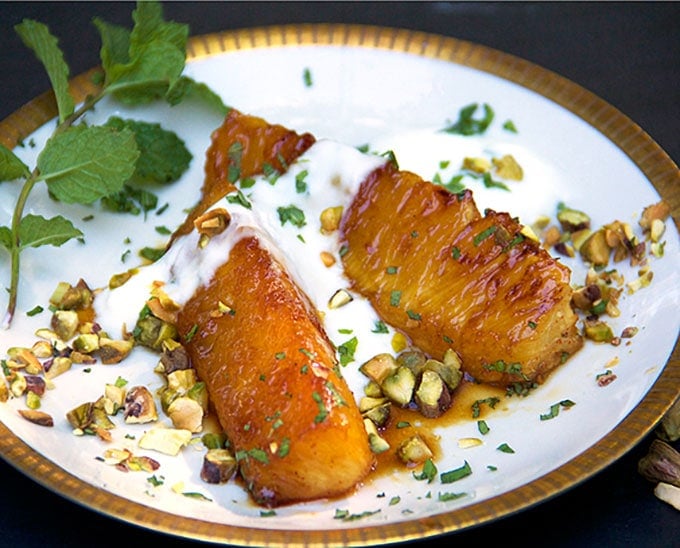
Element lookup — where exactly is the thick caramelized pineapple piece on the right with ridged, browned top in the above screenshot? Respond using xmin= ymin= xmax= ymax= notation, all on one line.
xmin=341 ymin=164 xmax=582 ymax=385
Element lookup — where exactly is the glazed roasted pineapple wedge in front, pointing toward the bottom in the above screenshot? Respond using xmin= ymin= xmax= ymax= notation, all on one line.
xmin=178 ymin=229 xmax=374 ymax=506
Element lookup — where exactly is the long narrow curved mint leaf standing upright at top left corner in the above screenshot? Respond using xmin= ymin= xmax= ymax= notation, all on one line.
xmin=14 ymin=19 xmax=75 ymax=122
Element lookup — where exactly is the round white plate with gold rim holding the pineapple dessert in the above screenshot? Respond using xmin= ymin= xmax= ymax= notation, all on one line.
xmin=0 ymin=25 xmax=680 ymax=546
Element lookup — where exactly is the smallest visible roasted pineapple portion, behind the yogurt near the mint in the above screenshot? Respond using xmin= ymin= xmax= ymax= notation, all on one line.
xmin=173 ymin=109 xmax=315 ymax=239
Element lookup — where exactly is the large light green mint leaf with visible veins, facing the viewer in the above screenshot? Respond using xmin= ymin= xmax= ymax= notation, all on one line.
xmin=38 ymin=125 xmax=139 ymax=204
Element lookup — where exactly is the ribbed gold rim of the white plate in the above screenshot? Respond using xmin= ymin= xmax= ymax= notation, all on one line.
xmin=0 ymin=24 xmax=680 ymax=546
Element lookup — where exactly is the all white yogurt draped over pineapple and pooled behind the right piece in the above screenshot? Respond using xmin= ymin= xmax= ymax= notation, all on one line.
xmin=95 ymin=131 xmax=557 ymax=363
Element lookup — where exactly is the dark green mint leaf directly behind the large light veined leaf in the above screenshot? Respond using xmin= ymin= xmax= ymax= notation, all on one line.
xmin=105 ymin=116 xmax=192 ymax=183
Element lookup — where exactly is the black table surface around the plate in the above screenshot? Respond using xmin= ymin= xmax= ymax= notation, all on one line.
xmin=0 ymin=2 xmax=680 ymax=547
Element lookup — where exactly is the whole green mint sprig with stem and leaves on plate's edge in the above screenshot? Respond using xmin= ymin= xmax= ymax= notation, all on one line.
xmin=0 ymin=1 xmax=228 ymax=328
